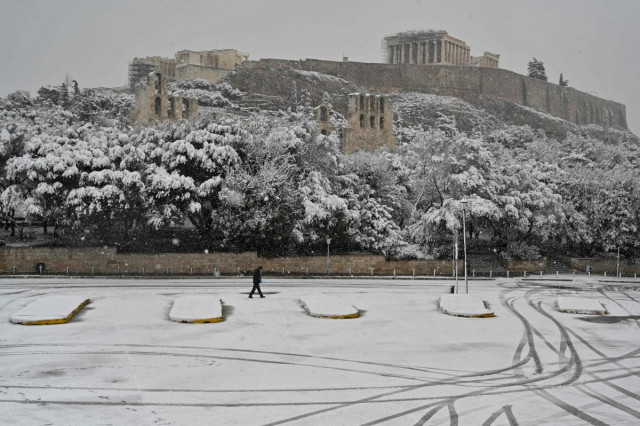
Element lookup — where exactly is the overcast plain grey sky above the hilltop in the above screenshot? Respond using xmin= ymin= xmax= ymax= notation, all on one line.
xmin=0 ymin=0 xmax=640 ymax=134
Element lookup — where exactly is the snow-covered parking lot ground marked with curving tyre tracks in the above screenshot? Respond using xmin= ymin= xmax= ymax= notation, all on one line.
xmin=0 ymin=277 xmax=640 ymax=425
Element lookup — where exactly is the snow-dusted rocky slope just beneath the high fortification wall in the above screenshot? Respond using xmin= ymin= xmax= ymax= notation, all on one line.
xmin=227 ymin=67 xmax=639 ymax=143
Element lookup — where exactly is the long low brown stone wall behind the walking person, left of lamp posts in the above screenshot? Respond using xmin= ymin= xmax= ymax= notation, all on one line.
xmin=0 ymin=247 xmax=463 ymax=276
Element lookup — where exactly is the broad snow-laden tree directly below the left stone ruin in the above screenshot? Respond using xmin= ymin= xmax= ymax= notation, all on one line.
xmin=136 ymin=121 xmax=244 ymax=243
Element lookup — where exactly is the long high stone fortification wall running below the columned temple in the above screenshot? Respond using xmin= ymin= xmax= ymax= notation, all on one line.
xmin=243 ymin=59 xmax=627 ymax=129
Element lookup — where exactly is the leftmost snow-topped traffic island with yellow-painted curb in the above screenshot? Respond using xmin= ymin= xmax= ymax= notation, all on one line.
xmin=11 ymin=296 xmax=90 ymax=325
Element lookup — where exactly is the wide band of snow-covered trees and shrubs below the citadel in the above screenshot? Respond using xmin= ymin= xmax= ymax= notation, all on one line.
xmin=0 ymin=81 xmax=640 ymax=259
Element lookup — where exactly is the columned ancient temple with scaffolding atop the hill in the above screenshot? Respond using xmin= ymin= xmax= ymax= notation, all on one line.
xmin=384 ymin=30 xmax=499 ymax=68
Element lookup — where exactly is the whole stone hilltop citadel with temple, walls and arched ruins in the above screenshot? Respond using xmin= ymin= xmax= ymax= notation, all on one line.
xmin=129 ymin=31 xmax=627 ymax=153
